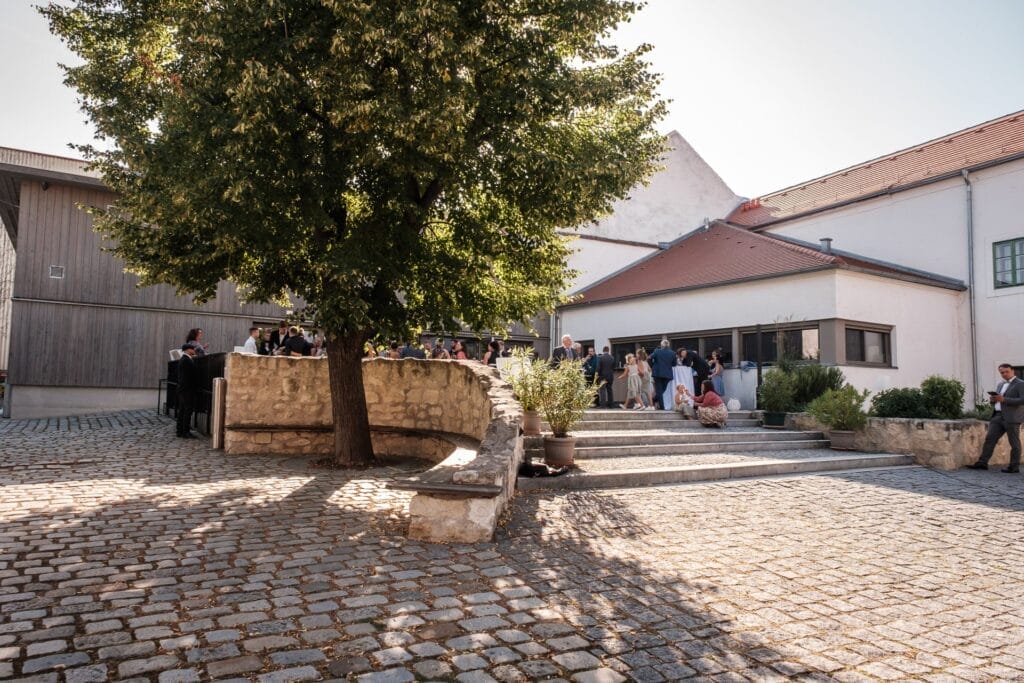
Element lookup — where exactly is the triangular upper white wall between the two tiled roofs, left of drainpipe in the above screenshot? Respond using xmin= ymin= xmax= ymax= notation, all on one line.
xmin=768 ymin=179 xmax=968 ymax=283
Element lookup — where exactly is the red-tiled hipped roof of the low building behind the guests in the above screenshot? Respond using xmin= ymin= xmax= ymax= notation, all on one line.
xmin=566 ymin=221 xmax=964 ymax=306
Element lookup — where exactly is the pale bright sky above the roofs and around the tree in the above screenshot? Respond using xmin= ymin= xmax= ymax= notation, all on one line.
xmin=0 ymin=0 xmax=1024 ymax=197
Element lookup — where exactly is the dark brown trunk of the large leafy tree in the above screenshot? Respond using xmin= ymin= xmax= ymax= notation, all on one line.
xmin=327 ymin=332 xmax=374 ymax=467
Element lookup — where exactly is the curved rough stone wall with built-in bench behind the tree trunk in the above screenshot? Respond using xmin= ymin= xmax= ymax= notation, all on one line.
xmin=224 ymin=353 xmax=523 ymax=543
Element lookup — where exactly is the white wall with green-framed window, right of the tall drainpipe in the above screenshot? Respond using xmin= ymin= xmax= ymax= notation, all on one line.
xmin=971 ymin=161 xmax=1024 ymax=395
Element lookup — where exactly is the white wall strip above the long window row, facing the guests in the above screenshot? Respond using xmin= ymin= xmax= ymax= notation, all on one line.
xmin=552 ymin=270 xmax=836 ymax=356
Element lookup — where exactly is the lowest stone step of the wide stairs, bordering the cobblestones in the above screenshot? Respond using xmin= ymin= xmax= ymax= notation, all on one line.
xmin=518 ymin=452 xmax=913 ymax=490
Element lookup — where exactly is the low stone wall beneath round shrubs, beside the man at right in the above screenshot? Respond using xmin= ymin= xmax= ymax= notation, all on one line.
xmin=785 ymin=413 xmax=1010 ymax=470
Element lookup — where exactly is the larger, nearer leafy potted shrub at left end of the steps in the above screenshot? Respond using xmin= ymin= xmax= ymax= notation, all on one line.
xmin=541 ymin=360 xmax=600 ymax=467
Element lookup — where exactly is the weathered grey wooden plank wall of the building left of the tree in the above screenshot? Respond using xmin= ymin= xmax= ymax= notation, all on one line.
xmin=8 ymin=181 xmax=284 ymax=388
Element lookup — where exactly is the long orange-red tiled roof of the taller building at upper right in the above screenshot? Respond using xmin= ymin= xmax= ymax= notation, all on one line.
xmin=727 ymin=112 xmax=1024 ymax=227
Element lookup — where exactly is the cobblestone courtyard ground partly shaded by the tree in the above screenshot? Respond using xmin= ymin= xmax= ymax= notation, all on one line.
xmin=0 ymin=414 xmax=1024 ymax=683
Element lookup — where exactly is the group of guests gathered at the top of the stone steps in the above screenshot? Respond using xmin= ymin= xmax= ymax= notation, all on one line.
xmin=551 ymin=335 xmax=729 ymax=427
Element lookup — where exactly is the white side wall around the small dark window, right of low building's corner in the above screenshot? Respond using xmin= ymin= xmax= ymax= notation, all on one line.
xmin=836 ymin=271 xmax=972 ymax=402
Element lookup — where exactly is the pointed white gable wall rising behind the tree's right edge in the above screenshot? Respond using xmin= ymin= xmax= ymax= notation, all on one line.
xmin=581 ymin=131 xmax=740 ymax=244
